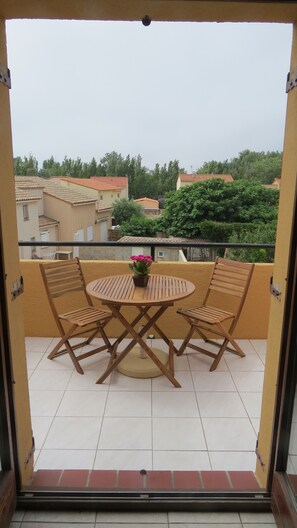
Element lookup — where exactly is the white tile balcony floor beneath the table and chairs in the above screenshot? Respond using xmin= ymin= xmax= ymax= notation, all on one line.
xmin=26 ymin=337 xmax=266 ymax=471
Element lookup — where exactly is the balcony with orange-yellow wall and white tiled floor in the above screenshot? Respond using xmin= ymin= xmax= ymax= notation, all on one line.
xmin=21 ymin=261 xmax=273 ymax=478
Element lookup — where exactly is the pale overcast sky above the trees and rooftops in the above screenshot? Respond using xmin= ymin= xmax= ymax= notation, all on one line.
xmin=7 ymin=21 xmax=292 ymax=172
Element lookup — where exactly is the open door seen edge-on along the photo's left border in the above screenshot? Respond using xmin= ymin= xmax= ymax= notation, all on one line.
xmin=0 ymin=218 xmax=16 ymax=528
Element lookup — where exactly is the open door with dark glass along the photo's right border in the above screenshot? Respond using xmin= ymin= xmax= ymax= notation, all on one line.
xmin=272 ymin=183 xmax=297 ymax=528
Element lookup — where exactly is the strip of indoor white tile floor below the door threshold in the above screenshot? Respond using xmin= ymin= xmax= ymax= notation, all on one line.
xmin=10 ymin=511 xmax=276 ymax=528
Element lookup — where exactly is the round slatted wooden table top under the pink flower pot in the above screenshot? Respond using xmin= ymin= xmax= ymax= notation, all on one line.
xmin=87 ymin=273 xmax=195 ymax=305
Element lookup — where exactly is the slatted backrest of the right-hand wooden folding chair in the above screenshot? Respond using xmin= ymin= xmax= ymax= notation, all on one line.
xmin=203 ymin=257 xmax=254 ymax=315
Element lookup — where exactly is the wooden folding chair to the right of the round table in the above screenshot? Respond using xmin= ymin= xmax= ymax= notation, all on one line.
xmin=177 ymin=257 xmax=254 ymax=371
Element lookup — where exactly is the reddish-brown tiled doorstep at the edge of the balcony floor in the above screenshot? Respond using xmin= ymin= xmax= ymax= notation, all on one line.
xmin=26 ymin=469 xmax=265 ymax=492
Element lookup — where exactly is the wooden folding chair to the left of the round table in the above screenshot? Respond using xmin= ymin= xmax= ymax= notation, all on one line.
xmin=40 ymin=258 xmax=114 ymax=374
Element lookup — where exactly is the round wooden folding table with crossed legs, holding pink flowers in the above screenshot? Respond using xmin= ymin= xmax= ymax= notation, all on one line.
xmin=87 ymin=274 xmax=195 ymax=387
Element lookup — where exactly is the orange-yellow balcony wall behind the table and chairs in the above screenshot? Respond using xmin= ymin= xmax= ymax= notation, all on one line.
xmin=20 ymin=260 xmax=273 ymax=339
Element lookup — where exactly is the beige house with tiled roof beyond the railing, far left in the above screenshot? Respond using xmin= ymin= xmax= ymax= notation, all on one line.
xmin=15 ymin=176 xmax=111 ymax=259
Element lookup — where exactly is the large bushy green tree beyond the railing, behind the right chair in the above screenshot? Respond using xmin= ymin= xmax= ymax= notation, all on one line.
xmin=160 ymin=179 xmax=279 ymax=238
